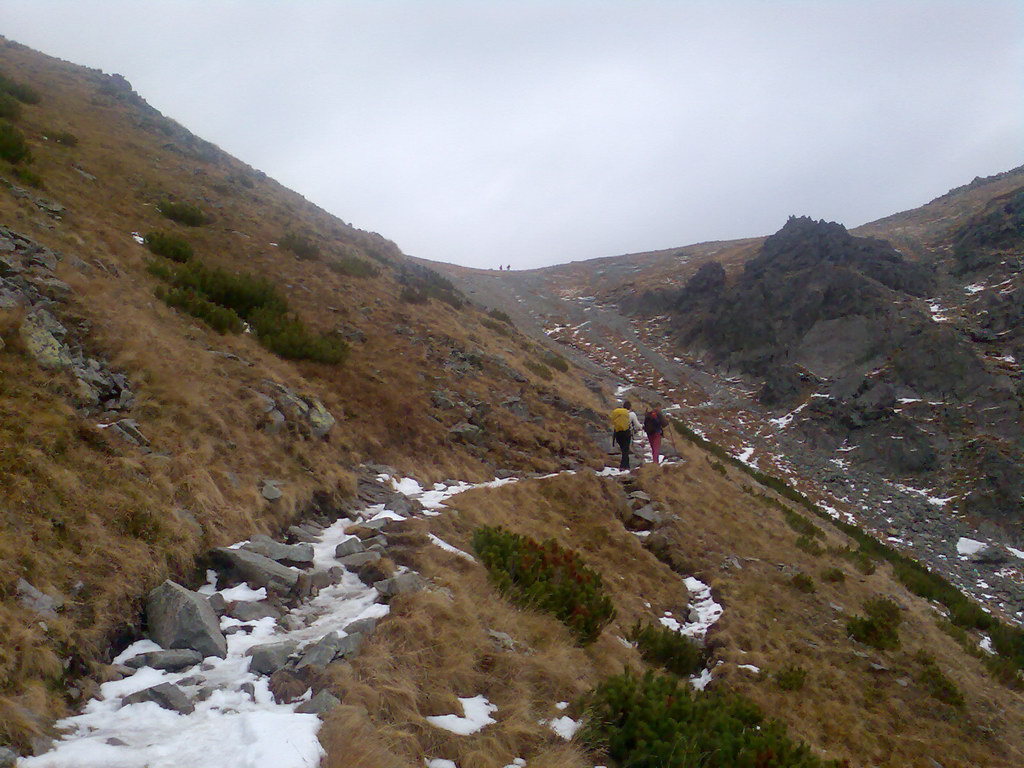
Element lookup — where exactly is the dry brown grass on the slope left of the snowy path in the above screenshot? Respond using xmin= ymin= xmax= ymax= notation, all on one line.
xmin=0 ymin=36 xmax=596 ymax=746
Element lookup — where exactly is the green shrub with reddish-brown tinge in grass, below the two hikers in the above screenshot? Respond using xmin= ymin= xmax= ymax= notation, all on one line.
xmin=473 ymin=526 xmax=615 ymax=645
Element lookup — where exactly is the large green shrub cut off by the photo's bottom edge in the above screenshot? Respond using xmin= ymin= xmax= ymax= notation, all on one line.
xmin=580 ymin=673 xmax=838 ymax=768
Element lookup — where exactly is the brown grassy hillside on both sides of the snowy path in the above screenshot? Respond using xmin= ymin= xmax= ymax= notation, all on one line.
xmin=0 ymin=36 xmax=1024 ymax=768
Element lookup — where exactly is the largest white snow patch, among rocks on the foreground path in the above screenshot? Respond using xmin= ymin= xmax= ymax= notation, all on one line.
xmin=20 ymin=493 xmax=401 ymax=768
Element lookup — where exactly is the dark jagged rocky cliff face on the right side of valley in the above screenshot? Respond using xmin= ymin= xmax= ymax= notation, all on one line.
xmin=659 ymin=217 xmax=1024 ymax=522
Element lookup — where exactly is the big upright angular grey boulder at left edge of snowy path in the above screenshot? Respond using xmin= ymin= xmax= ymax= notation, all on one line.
xmin=145 ymin=581 xmax=227 ymax=658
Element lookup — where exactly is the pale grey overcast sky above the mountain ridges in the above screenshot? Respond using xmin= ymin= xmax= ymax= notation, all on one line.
xmin=0 ymin=0 xmax=1024 ymax=267
